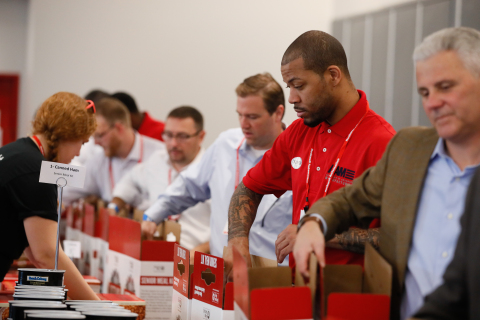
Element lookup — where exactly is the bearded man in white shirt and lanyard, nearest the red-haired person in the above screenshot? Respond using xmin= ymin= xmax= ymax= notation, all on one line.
xmin=63 ymin=98 xmax=165 ymax=205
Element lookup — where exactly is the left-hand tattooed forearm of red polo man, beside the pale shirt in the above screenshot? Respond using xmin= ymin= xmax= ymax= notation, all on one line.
xmin=228 ymin=182 xmax=263 ymax=240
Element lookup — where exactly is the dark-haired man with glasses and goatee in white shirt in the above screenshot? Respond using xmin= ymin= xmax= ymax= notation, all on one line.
xmin=109 ymin=106 xmax=210 ymax=253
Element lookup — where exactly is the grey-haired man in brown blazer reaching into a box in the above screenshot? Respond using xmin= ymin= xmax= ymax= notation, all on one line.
xmin=294 ymin=27 xmax=480 ymax=319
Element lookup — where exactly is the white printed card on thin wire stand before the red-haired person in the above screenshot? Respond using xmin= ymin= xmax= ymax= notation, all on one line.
xmin=39 ymin=161 xmax=86 ymax=188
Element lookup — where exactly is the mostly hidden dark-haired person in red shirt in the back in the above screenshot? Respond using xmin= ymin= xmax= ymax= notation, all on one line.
xmin=112 ymin=92 xmax=165 ymax=141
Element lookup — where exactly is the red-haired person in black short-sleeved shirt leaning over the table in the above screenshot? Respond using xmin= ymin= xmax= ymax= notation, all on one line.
xmin=0 ymin=92 xmax=98 ymax=300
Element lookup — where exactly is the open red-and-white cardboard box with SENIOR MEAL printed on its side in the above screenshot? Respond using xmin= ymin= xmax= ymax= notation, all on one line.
xmin=103 ymin=216 xmax=180 ymax=320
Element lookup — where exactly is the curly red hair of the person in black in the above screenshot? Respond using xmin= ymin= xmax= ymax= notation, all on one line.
xmin=32 ymin=92 xmax=97 ymax=161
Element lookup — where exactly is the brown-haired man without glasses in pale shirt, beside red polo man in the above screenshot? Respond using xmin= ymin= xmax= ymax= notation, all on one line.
xmin=142 ymin=73 xmax=292 ymax=259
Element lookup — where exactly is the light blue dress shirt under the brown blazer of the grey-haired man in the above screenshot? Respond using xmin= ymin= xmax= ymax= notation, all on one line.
xmin=401 ymin=138 xmax=478 ymax=319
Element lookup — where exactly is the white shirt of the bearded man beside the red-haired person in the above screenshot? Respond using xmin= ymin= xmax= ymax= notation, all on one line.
xmin=63 ymin=132 xmax=165 ymax=205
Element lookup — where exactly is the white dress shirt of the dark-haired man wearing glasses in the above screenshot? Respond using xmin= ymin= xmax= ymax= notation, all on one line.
xmin=113 ymin=149 xmax=210 ymax=250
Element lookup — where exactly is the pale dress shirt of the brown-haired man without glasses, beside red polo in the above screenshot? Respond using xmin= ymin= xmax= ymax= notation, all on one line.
xmin=144 ymin=128 xmax=292 ymax=263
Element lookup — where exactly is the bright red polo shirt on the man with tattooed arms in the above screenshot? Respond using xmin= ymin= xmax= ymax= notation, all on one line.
xmin=243 ymin=90 xmax=395 ymax=265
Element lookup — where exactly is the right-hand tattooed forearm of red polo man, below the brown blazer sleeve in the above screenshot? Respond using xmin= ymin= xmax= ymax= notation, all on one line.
xmin=327 ymin=228 xmax=380 ymax=253
